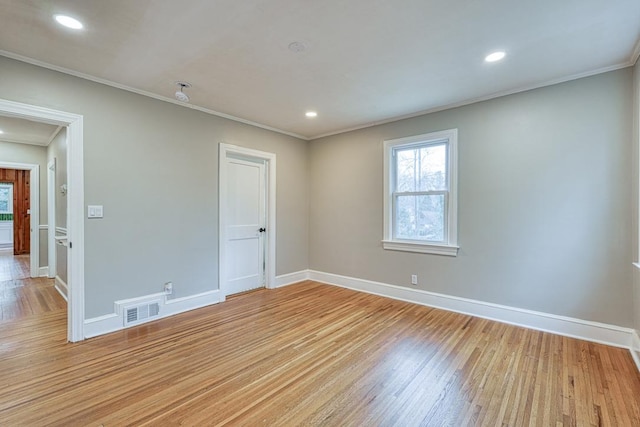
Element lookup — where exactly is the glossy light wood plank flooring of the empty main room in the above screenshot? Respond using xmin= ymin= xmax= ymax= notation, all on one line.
xmin=0 ymin=282 xmax=640 ymax=426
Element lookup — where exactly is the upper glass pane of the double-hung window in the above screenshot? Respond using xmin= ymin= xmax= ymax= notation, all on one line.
xmin=396 ymin=144 xmax=447 ymax=193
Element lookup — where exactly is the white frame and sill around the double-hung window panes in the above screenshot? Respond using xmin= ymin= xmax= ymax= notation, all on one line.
xmin=382 ymin=129 xmax=459 ymax=256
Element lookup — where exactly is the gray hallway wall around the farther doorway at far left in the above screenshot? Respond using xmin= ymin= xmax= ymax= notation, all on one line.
xmin=0 ymin=140 xmax=49 ymax=267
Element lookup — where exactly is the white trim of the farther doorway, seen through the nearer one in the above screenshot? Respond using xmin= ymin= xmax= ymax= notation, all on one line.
xmin=0 ymin=161 xmax=40 ymax=277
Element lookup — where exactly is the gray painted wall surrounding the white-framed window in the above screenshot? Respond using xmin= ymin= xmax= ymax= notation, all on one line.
xmin=309 ymin=68 xmax=632 ymax=326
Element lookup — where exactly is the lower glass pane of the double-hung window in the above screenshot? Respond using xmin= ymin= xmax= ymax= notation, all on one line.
xmin=394 ymin=194 xmax=444 ymax=242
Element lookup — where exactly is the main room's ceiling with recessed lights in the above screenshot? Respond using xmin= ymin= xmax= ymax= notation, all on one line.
xmin=0 ymin=0 xmax=640 ymax=139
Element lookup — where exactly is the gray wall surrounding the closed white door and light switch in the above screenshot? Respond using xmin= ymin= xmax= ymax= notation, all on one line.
xmin=0 ymin=57 xmax=308 ymax=318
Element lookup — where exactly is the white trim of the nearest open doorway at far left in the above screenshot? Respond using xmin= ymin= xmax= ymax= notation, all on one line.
xmin=0 ymin=99 xmax=84 ymax=342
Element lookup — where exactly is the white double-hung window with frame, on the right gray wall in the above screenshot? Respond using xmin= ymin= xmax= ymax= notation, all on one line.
xmin=382 ymin=129 xmax=458 ymax=256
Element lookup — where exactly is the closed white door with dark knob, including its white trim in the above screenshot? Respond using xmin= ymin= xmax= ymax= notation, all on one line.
xmin=218 ymin=144 xmax=276 ymax=301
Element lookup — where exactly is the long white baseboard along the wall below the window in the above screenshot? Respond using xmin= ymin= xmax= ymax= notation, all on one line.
xmin=308 ymin=270 xmax=632 ymax=349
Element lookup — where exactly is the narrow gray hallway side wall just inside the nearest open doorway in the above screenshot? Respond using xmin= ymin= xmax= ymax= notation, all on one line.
xmin=47 ymin=128 xmax=67 ymax=283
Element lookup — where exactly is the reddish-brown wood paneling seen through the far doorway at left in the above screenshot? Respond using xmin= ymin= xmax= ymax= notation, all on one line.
xmin=0 ymin=169 xmax=31 ymax=255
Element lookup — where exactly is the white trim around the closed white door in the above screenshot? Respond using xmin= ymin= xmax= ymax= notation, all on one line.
xmin=218 ymin=143 xmax=276 ymax=301
